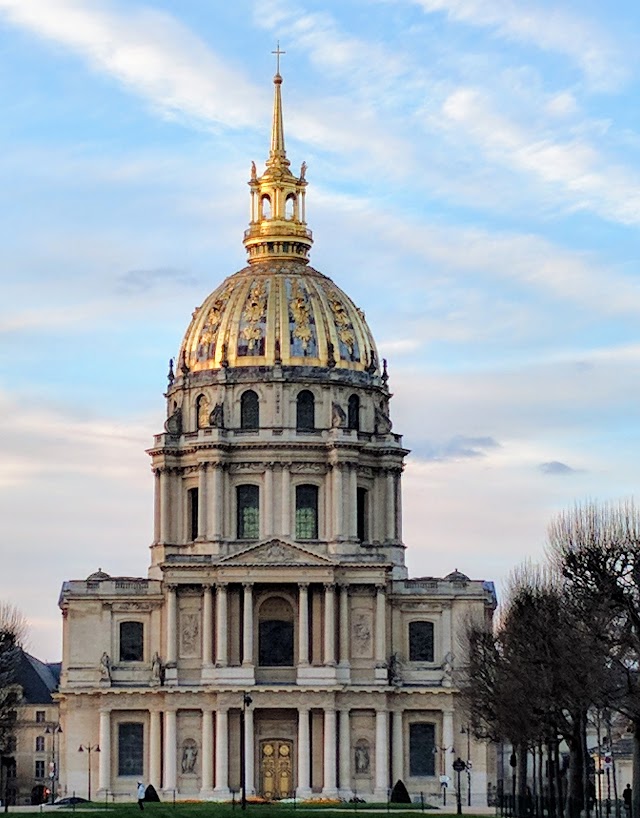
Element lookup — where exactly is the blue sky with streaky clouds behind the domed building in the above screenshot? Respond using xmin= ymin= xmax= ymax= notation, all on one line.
xmin=0 ymin=0 xmax=640 ymax=661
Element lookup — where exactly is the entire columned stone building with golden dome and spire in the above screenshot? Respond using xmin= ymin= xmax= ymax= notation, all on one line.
xmin=59 ymin=67 xmax=495 ymax=803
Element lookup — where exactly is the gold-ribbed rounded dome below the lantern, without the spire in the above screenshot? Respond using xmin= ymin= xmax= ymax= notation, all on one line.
xmin=176 ymin=259 xmax=378 ymax=375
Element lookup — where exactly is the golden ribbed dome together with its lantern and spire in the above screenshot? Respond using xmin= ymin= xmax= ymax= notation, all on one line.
xmin=178 ymin=71 xmax=380 ymax=376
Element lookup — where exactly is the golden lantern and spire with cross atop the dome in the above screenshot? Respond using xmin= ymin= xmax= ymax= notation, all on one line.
xmin=244 ymin=52 xmax=313 ymax=264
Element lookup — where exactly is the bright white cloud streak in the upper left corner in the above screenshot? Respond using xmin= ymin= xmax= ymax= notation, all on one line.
xmin=0 ymin=0 xmax=267 ymax=127
